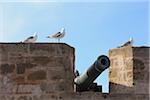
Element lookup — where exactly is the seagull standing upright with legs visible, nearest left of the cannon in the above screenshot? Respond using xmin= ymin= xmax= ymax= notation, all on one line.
xmin=47 ymin=28 xmax=65 ymax=42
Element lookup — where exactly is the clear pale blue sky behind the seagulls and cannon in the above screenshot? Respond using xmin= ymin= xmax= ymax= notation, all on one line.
xmin=0 ymin=0 xmax=150 ymax=92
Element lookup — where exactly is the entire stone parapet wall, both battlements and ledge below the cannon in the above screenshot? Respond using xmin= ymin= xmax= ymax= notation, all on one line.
xmin=0 ymin=43 xmax=150 ymax=100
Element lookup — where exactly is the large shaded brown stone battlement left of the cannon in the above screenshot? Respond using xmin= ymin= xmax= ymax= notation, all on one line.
xmin=0 ymin=43 xmax=75 ymax=100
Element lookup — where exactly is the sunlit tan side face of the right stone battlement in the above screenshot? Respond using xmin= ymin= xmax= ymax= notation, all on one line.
xmin=109 ymin=46 xmax=133 ymax=88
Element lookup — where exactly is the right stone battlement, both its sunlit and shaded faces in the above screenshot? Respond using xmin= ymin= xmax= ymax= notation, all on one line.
xmin=109 ymin=46 xmax=149 ymax=96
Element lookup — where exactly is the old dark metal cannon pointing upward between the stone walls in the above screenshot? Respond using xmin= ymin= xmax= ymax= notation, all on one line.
xmin=74 ymin=55 xmax=110 ymax=91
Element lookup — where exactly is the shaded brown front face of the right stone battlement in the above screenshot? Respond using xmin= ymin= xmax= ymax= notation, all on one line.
xmin=133 ymin=47 xmax=150 ymax=94
